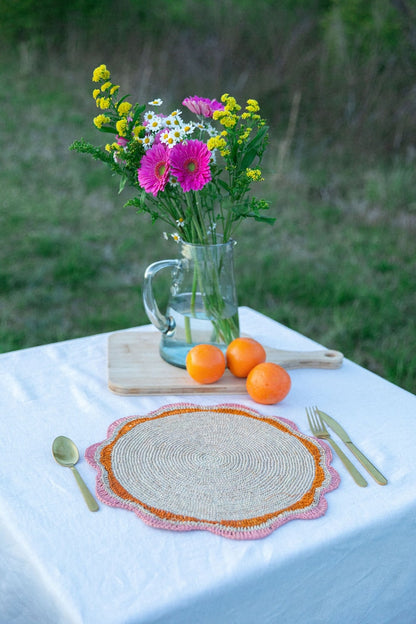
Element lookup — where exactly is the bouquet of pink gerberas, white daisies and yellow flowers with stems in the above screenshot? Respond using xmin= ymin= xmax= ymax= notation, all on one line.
xmin=70 ymin=65 xmax=274 ymax=364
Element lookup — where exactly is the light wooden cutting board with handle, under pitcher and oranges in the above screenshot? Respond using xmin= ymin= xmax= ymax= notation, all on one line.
xmin=108 ymin=331 xmax=343 ymax=395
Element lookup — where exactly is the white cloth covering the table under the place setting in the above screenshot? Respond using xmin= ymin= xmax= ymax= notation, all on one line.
xmin=0 ymin=308 xmax=416 ymax=624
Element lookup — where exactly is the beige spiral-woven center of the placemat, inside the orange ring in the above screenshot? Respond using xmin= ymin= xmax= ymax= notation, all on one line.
xmin=111 ymin=410 xmax=315 ymax=521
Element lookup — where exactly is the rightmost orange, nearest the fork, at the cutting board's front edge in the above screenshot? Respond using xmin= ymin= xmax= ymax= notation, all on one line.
xmin=246 ymin=362 xmax=292 ymax=405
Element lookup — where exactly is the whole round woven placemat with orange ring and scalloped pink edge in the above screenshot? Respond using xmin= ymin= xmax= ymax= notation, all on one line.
xmin=86 ymin=404 xmax=339 ymax=539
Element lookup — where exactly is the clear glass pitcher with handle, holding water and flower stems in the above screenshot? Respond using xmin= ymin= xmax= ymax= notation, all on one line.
xmin=143 ymin=241 xmax=239 ymax=368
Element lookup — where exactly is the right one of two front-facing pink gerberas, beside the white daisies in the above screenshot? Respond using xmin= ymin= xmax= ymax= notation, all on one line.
xmin=170 ymin=140 xmax=211 ymax=191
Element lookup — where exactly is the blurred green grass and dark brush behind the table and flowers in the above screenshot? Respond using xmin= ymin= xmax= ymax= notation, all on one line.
xmin=0 ymin=0 xmax=416 ymax=392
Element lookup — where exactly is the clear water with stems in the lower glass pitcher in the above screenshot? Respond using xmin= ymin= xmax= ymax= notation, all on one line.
xmin=160 ymin=293 xmax=239 ymax=368
